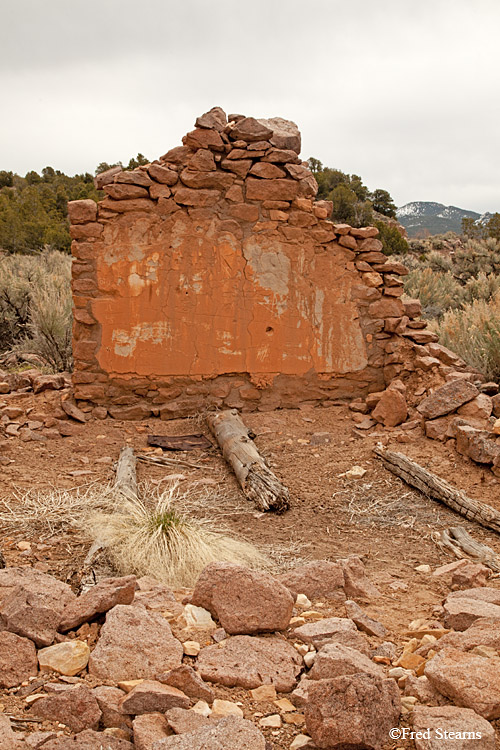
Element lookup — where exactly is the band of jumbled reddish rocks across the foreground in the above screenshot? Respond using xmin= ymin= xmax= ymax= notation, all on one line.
xmin=0 ymin=558 xmax=500 ymax=750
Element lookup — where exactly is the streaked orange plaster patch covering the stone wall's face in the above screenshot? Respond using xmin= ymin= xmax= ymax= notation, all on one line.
xmin=92 ymin=212 xmax=367 ymax=377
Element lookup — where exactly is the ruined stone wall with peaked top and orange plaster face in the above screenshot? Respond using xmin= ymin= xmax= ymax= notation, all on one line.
xmin=69 ymin=107 xmax=432 ymax=419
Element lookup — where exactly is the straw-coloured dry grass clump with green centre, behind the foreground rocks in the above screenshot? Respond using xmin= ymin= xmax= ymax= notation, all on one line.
xmin=90 ymin=484 xmax=270 ymax=587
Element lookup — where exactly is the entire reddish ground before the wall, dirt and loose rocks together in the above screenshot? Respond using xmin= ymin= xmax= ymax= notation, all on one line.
xmin=0 ymin=380 xmax=500 ymax=750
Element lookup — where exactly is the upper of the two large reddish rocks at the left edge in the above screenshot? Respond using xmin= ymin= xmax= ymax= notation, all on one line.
xmin=0 ymin=567 xmax=76 ymax=646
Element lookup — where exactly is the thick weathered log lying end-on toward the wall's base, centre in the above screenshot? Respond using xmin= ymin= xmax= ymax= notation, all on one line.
xmin=207 ymin=409 xmax=290 ymax=513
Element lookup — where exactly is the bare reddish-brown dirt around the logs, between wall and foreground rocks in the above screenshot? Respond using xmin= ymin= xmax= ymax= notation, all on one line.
xmin=0 ymin=394 xmax=500 ymax=750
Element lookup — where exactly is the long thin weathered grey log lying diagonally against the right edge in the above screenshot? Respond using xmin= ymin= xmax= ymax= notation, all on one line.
xmin=373 ymin=443 xmax=500 ymax=533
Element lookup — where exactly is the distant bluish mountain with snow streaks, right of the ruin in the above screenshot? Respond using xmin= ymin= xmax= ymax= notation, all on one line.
xmin=396 ymin=201 xmax=491 ymax=237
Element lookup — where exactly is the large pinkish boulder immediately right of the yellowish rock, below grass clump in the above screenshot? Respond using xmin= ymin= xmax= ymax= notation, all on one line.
xmin=89 ymin=604 xmax=183 ymax=682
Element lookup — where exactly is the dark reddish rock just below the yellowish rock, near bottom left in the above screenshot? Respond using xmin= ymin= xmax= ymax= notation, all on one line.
xmin=30 ymin=685 xmax=101 ymax=732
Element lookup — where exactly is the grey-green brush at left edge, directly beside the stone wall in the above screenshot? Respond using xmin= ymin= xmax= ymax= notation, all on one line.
xmin=0 ymin=250 xmax=72 ymax=371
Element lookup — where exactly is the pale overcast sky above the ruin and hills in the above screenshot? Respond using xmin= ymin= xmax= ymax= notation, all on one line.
xmin=0 ymin=0 xmax=500 ymax=212
